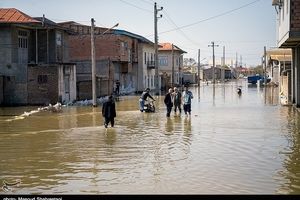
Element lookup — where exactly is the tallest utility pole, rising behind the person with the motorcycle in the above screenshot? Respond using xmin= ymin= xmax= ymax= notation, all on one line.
xmin=154 ymin=2 xmax=163 ymax=95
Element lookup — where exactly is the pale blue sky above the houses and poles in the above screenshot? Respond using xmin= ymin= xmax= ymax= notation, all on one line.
xmin=0 ymin=0 xmax=277 ymax=67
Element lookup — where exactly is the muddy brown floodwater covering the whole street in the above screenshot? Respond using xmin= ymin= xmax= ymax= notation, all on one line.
xmin=0 ymin=81 xmax=300 ymax=194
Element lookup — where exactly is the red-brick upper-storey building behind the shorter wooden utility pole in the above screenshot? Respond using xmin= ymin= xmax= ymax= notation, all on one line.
xmin=60 ymin=22 xmax=153 ymax=99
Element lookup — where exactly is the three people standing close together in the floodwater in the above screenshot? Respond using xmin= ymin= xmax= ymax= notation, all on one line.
xmin=164 ymin=86 xmax=194 ymax=117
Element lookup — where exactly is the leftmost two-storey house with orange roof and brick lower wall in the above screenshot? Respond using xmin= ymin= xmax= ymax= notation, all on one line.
xmin=0 ymin=8 xmax=76 ymax=105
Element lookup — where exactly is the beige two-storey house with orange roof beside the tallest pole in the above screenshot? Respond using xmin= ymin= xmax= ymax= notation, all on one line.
xmin=158 ymin=43 xmax=187 ymax=90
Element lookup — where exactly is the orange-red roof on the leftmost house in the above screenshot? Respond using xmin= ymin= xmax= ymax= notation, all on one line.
xmin=0 ymin=8 xmax=40 ymax=23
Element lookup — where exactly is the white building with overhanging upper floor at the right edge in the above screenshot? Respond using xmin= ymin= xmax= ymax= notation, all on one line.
xmin=272 ymin=0 xmax=300 ymax=107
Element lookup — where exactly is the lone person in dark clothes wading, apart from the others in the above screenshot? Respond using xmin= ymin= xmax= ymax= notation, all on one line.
xmin=102 ymin=96 xmax=116 ymax=128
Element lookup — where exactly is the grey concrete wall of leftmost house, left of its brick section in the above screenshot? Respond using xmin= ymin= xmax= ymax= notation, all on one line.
xmin=0 ymin=25 xmax=27 ymax=105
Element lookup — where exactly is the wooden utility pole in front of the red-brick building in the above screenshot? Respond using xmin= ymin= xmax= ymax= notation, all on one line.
xmin=91 ymin=18 xmax=97 ymax=107
